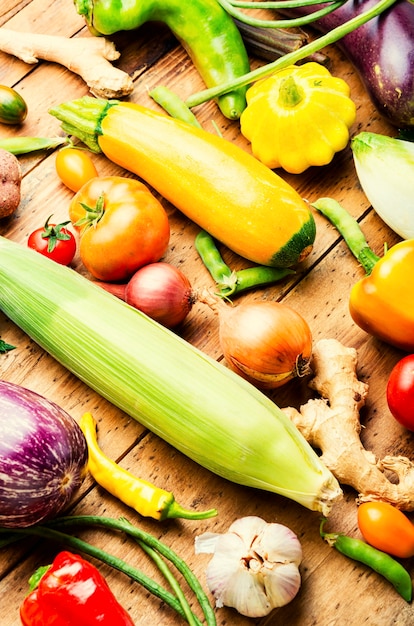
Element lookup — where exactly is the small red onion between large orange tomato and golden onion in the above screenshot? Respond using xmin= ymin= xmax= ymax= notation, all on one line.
xmin=98 ymin=261 xmax=196 ymax=328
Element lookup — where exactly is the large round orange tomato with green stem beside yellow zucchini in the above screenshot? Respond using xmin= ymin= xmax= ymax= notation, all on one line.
xmin=69 ymin=176 xmax=170 ymax=282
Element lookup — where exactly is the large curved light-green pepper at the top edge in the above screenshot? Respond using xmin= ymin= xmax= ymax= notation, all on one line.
xmin=74 ymin=0 xmax=250 ymax=119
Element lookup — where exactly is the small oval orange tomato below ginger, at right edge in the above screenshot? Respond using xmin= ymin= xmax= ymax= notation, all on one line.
xmin=358 ymin=502 xmax=414 ymax=559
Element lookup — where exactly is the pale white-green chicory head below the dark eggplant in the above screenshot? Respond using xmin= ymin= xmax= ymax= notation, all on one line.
xmin=351 ymin=132 xmax=414 ymax=239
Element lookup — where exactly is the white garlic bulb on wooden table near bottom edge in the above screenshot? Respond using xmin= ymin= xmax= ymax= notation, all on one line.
xmin=195 ymin=516 xmax=302 ymax=617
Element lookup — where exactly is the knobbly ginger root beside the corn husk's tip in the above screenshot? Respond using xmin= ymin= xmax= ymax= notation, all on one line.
xmin=283 ymin=339 xmax=414 ymax=511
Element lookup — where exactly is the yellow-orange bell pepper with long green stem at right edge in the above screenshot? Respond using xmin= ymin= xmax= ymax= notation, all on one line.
xmin=312 ymin=198 xmax=414 ymax=352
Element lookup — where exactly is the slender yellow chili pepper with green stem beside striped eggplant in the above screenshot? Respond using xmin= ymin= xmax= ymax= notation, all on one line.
xmin=79 ymin=413 xmax=217 ymax=521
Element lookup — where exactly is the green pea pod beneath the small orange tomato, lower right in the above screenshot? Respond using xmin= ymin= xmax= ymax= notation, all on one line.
xmin=320 ymin=519 xmax=413 ymax=602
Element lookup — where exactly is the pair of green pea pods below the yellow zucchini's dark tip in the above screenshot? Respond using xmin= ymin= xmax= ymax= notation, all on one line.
xmin=195 ymin=230 xmax=295 ymax=298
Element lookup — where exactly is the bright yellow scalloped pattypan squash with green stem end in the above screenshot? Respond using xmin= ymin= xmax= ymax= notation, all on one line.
xmin=240 ymin=62 xmax=356 ymax=174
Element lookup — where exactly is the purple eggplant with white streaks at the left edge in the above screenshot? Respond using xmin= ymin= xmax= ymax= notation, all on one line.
xmin=0 ymin=381 xmax=88 ymax=528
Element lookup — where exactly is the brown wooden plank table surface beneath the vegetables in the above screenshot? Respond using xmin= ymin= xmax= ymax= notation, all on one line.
xmin=0 ymin=0 xmax=414 ymax=626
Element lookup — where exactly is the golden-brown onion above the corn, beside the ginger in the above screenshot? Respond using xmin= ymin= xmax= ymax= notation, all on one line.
xmin=219 ymin=302 xmax=312 ymax=389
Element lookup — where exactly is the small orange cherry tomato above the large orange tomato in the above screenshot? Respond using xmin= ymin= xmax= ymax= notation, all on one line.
xmin=55 ymin=148 xmax=98 ymax=192
